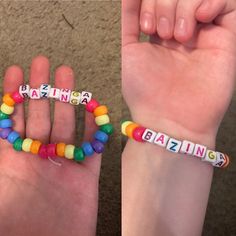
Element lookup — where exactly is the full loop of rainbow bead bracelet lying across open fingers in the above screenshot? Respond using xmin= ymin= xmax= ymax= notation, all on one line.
xmin=0 ymin=84 xmax=113 ymax=162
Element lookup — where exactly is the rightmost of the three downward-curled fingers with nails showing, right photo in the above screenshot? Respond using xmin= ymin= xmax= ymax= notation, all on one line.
xmin=174 ymin=0 xmax=201 ymax=43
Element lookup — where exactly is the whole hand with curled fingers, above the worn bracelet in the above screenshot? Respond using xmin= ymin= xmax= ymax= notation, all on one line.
xmin=122 ymin=0 xmax=236 ymax=146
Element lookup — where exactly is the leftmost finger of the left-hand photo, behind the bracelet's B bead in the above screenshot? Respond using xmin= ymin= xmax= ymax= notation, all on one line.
xmin=3 ymin=66 xmax=25 ymax=135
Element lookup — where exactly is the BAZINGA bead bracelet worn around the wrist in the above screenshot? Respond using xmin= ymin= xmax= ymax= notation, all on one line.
xmin=121 ymin=121 xmax=230 ymax=168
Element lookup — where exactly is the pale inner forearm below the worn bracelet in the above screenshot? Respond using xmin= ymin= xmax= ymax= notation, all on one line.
xmin=122 ymin=140 xmax=213 ymax=236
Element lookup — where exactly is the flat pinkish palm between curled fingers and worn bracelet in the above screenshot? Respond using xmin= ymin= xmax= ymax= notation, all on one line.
xmin=123 ymin=24 xmax=236 ymax=138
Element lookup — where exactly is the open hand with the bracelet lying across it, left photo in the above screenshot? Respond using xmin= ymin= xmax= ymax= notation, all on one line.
xmin=0 ymin=56 xmax=101 ymax=236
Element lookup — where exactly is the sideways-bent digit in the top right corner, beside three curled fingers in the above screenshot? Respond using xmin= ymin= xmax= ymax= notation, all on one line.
xmin=196 ymin=0 xmax=236 ymax=33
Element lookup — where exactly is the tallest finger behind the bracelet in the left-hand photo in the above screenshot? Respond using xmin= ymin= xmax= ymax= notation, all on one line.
xmin=26 ymin=56 xmax=51 ymax=143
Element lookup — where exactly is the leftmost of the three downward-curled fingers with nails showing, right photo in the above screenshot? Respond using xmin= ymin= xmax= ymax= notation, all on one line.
xmin=140 ymin=0 xmax=156 ymax=35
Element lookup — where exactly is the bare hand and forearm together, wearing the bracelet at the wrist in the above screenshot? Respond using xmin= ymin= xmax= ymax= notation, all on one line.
xmin=122 ymin=0 xmax=236 ymax=236
